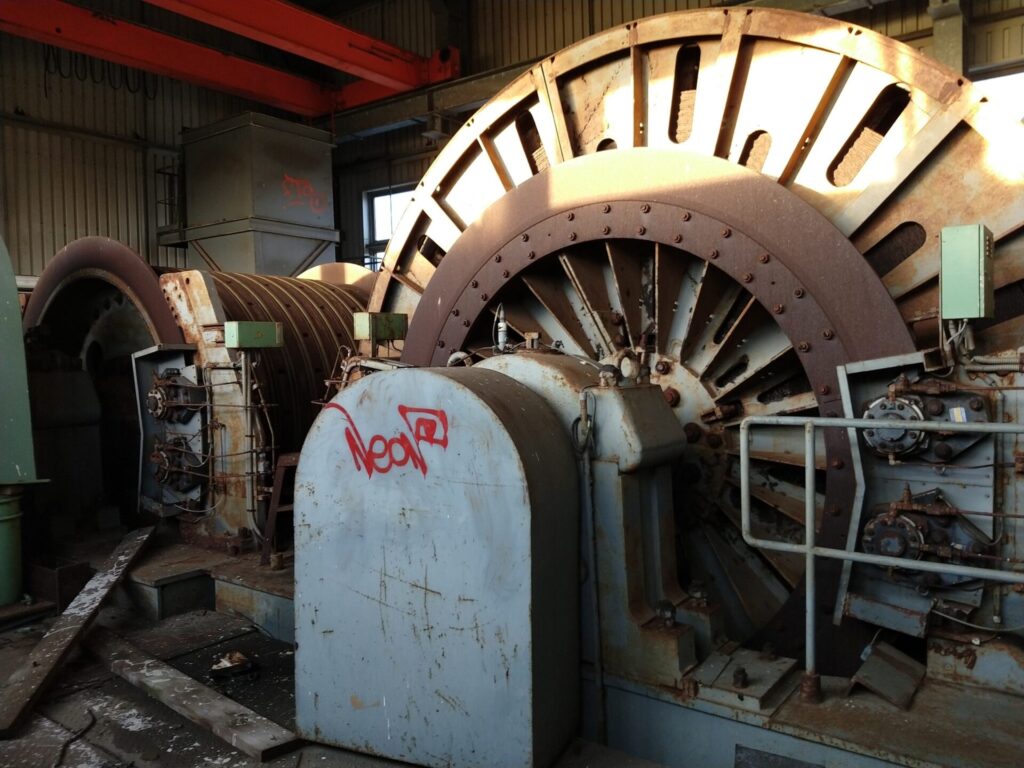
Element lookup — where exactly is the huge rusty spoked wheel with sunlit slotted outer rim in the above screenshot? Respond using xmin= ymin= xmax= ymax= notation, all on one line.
xmin=370 ymin=8 xmax=1024 ymax=663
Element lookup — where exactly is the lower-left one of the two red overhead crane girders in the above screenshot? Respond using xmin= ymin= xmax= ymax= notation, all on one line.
xmin=0 ymin=0 xmax=335 ymax=117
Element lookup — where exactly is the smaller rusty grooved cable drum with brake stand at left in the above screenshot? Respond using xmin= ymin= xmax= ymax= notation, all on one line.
xmin=25 ymin=238 xmax=367 ymax=552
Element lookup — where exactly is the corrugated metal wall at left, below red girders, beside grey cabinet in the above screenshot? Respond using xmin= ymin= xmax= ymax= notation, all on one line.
xmin=0 ymin=35 xmax=253 ymax=274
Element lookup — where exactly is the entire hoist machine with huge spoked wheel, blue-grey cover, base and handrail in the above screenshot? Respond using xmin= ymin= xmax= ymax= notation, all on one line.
xmin=296 ymin=8 xmax=1024 ymax=767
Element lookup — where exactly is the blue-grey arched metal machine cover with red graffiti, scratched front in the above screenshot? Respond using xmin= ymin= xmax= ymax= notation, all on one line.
xmin=295 ymin=369 xmax=579 ymax=767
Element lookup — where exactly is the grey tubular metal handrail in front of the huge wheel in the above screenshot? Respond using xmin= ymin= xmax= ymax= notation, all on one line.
xmin=739 ymin=416 xmax=1024 ymax=697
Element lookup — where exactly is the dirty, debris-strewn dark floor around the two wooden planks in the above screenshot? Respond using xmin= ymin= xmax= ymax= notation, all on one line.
xmin=0 ymin=608 xmax=652 ymax=768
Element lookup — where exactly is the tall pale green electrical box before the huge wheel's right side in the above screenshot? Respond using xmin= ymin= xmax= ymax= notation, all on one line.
xmin=939 ymin=224 xmax=995 ymax=319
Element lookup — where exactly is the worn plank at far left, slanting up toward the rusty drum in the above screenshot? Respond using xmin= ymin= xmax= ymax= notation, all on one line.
xmin=0 ymin=527 xmax=153 ymax=738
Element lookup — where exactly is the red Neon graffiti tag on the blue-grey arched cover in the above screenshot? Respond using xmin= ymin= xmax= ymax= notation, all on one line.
xmin=326 ymin=402 xmax=447 ymax=477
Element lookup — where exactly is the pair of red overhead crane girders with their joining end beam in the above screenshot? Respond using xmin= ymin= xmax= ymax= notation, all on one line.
xmin=0 ymin=0 xmax=459 ymax=117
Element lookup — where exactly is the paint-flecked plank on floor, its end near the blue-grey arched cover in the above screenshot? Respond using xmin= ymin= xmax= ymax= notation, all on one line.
xmin=85 ymin=627 xmax=301 ymax=761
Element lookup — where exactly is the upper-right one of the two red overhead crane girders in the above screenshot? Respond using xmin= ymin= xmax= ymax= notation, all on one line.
xmin=139 ymin=0 xmax=455 ymax=90
